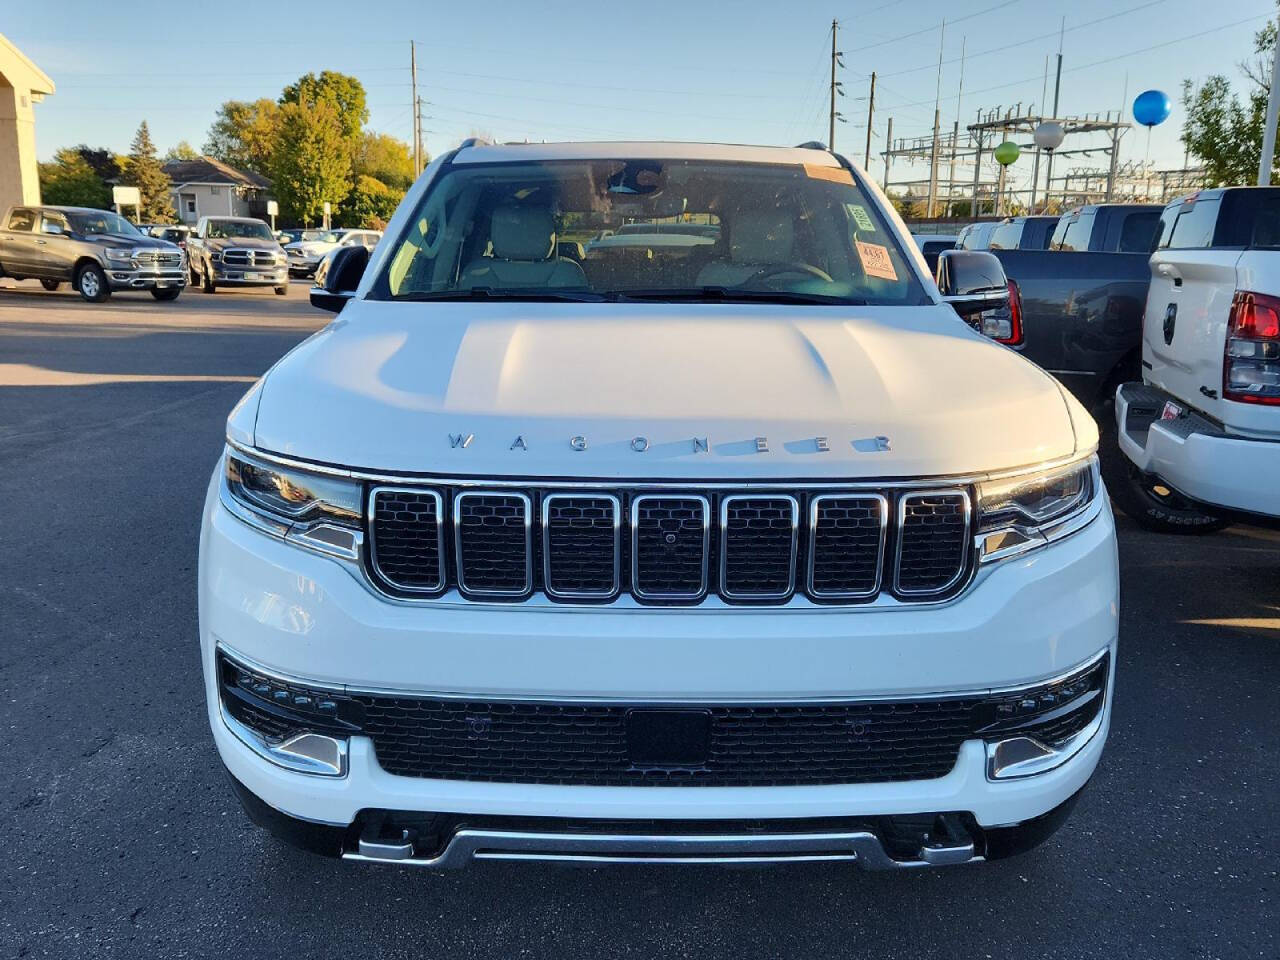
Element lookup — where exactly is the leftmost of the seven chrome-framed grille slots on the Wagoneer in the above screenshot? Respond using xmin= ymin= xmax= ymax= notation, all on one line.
xmin=370 ymin=486 xmax=444 ymax=594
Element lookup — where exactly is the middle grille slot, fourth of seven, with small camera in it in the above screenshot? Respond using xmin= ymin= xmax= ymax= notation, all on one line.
xmin=631 ymin=495 xmax=710 ymax=600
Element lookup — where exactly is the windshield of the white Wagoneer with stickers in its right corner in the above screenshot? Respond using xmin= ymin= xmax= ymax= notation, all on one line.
xmin=370 ymin=159 xmax=929 ymax=305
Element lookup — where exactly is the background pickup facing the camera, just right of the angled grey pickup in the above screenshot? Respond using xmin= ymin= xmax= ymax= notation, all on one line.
xmin=187 ymin=216 xmax=289 ymax=297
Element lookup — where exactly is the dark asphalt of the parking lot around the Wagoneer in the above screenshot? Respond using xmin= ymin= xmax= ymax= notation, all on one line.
xmin=0 ymin=280 xmax=1280 ymax=960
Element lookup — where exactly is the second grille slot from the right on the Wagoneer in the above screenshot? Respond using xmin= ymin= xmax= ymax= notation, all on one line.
xmin=809 ymin=494 xmax=888 ymax=600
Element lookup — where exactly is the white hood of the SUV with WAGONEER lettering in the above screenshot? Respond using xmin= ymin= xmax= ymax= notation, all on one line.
xmin=253 ymin=301 xmax=1075 ymax=480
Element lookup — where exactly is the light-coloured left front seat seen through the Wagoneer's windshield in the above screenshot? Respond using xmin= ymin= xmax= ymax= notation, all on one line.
xmin=458 ymin=205 xmax=586 ymax=291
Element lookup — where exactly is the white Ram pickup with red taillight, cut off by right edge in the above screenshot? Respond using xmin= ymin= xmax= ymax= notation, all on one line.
xmin=1111 ymin=187 xmax=1280 ymax=532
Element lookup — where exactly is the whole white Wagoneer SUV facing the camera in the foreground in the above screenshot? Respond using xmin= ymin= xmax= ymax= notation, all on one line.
xmin=200 ymin=142 xmax=1119 ymax=868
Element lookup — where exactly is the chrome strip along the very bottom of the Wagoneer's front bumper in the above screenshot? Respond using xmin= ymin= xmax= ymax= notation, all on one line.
xmin=343 ymin=820 xmax=983 ymax=870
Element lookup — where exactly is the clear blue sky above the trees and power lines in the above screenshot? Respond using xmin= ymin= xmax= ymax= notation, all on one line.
xmin=0 ymin=0 xmax=1276 ymax=195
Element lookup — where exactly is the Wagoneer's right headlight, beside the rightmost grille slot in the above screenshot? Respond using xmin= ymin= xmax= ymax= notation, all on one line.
xmin=978 ymin=456 xmax=1102 ymax=561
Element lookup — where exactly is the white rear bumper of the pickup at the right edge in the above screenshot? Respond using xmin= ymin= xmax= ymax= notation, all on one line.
xmin=1116 ymin=383 xmax=1280 ymax=517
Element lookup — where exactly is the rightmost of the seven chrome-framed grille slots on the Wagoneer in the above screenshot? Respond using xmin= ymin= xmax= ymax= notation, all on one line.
xmin=895 ymin=490 xmax=970 ymax=596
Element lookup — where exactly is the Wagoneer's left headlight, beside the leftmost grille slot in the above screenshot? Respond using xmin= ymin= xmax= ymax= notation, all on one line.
xmin=224 ymin=449 xmax=364 ymax=559
